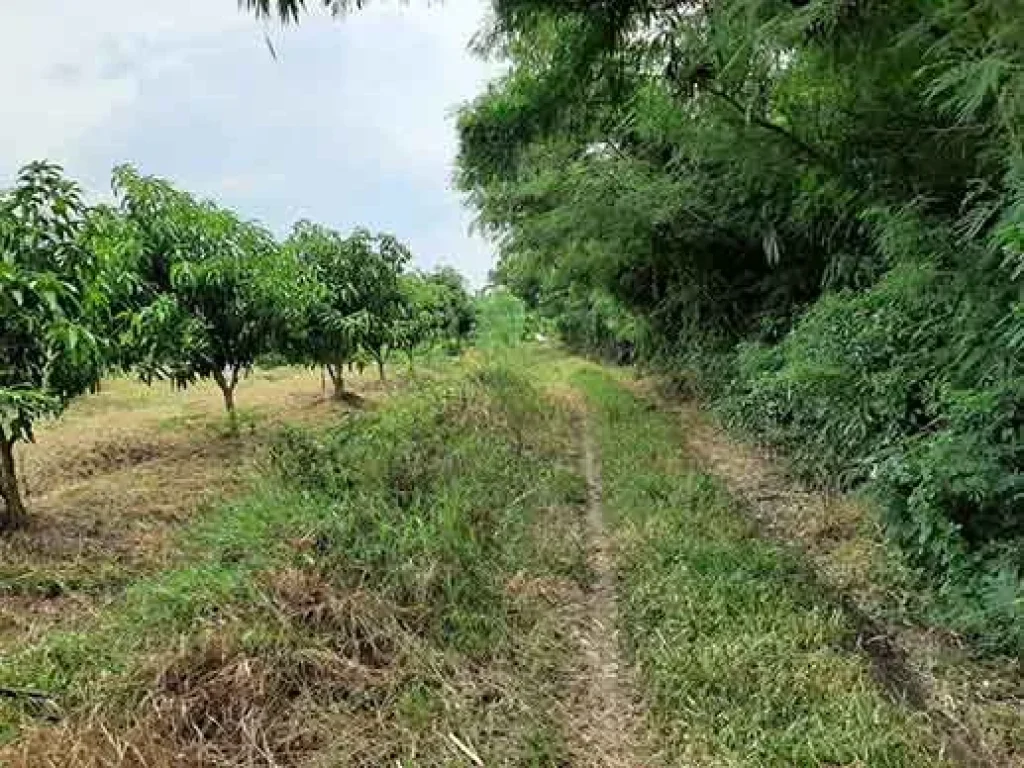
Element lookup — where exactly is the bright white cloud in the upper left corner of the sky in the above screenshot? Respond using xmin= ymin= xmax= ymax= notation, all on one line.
xmin=0 ymin=0 xmax=248 ymax=167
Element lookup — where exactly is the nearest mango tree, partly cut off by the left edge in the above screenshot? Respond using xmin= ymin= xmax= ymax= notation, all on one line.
xmin=0 ymin=163 xmax=104 ymax=530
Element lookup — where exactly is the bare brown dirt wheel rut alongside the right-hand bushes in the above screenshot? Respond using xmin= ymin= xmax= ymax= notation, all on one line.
xmin=651 ymin=393 xmax=1024 ymax=767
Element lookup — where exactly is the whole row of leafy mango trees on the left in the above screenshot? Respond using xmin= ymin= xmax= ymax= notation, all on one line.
xmin=0 ymin=163 xmax=474 ymax=529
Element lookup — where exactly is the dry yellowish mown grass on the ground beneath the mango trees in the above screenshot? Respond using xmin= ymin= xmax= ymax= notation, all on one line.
xmin=0 ymin=369 xmax=385 ymax=649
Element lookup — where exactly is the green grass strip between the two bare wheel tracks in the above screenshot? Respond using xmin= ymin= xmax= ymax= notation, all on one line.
xmin=574 ymin=370 xmax=945 ymax=768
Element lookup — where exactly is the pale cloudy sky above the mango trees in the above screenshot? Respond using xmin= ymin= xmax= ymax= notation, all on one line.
xmin=0 ymin=0 xmax=500 ymax=287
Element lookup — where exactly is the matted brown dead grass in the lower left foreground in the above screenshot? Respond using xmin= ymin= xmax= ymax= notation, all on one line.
xmin=5 ymin=569 xmax=412 ymax=768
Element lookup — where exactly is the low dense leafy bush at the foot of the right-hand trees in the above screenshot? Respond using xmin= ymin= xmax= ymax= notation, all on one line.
xmin=719 ymin=256 xmax=1024 ymax=648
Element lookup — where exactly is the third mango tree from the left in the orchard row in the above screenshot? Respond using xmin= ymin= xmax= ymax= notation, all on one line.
xmin=283 ymin=221 xmax=370 ymax=399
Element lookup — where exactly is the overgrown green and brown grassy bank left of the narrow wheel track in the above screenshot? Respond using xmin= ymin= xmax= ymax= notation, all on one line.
xmin=0 ymin=368 xmax=587 ymax=768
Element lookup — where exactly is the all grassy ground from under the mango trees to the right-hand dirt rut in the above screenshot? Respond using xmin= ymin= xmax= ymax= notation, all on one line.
xmin=0 ymin=348 xmax=1024 ymax=768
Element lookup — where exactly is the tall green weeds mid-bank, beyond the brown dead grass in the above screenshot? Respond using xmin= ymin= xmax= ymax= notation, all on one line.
xmin=272 ymin=367 xmax=566 ymax=650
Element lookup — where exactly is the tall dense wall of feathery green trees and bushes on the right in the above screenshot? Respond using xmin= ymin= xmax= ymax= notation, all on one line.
xmin=459 ymin=0 xmax=1024 ymax=651
